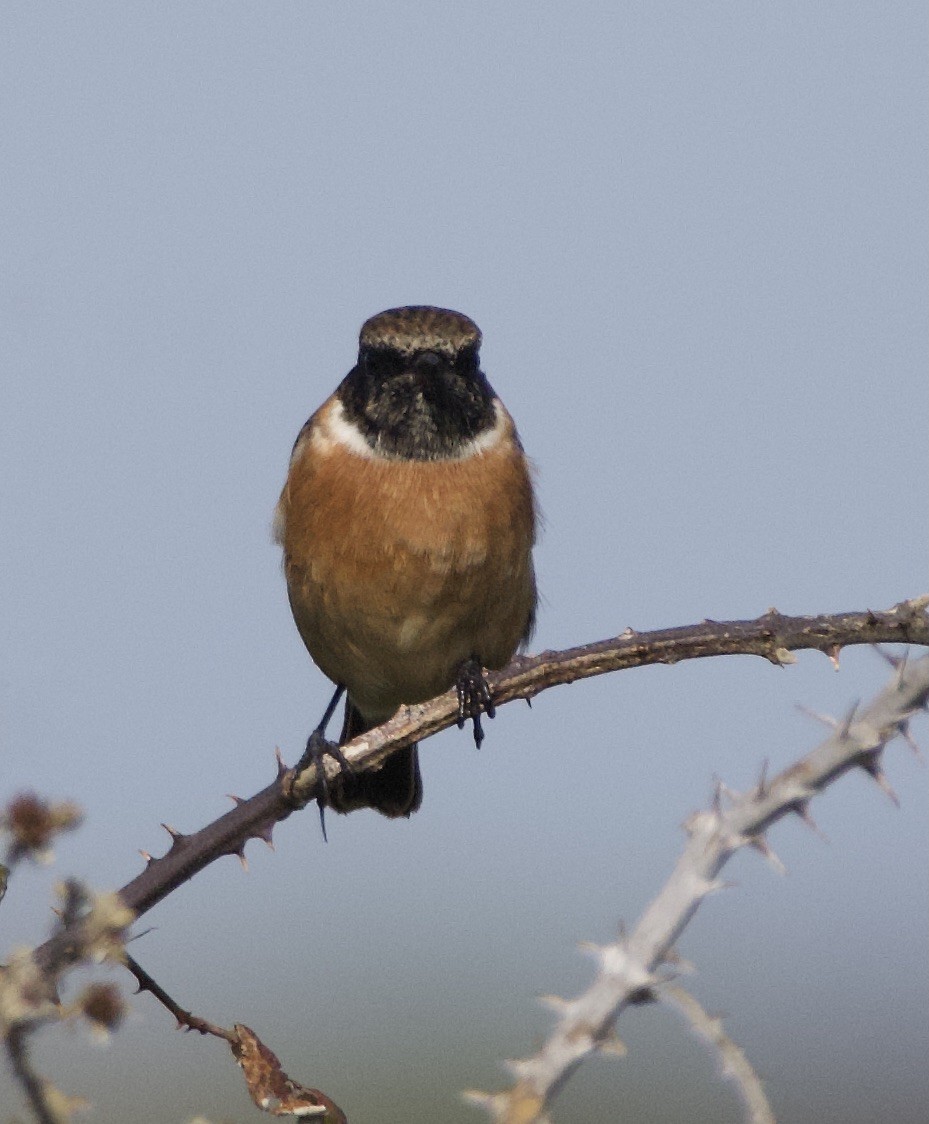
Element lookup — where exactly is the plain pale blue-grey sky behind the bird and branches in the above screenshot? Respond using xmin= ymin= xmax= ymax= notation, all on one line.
xmin=0 ymin=0 xmax=929 ymax=1124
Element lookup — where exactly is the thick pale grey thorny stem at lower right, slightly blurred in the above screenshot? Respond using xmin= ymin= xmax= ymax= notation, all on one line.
xmin=468 ymin=655 xmax=929 ymax=1124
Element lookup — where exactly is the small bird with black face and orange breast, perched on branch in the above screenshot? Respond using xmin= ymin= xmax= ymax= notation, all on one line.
xmin=274 ymin=305 xmax=538 ymax=835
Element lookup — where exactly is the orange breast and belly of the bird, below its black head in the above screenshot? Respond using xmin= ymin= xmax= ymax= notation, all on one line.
xmin=277 ymin=400 xmax=536 ymax=722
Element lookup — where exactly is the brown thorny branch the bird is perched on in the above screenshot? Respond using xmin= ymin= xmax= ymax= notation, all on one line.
xmin=36 ymin=595 xmax=929 ymax=967
